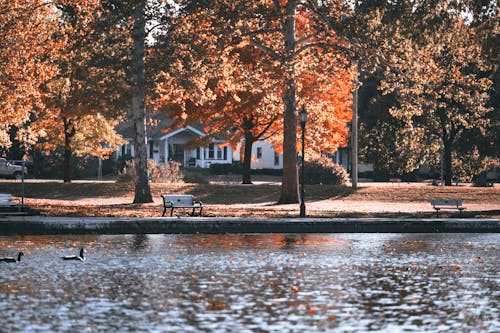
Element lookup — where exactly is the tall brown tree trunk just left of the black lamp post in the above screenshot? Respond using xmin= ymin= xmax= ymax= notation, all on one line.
xmin=279 ymin=0 xmax=299 ymax=204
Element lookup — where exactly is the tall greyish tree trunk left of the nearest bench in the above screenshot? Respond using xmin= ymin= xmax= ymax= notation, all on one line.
xmin=132 ymin=0 xmax=153 ymax=203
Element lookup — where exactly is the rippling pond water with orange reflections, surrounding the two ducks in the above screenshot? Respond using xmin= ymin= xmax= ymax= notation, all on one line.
xmin=0 ymin=234 xmax=500 ymax=332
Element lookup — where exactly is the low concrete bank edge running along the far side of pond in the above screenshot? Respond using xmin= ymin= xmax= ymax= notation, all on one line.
xmin=0 ymin=216 xmax=500 ymax=236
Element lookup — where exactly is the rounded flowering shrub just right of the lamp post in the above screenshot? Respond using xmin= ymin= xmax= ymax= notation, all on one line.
xmin=304 ymin=156 xmax=349 ymax=185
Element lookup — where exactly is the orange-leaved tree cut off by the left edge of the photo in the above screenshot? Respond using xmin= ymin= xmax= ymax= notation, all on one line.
xmin=0 ymin=0 xmax=61 ymax=148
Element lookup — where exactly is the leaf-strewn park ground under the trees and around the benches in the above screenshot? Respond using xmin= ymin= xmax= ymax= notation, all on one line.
xmin=0 ymin=176 xmax=500 ymax=218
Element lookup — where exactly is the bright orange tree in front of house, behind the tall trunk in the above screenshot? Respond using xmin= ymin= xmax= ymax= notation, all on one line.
xmin=154 ymin=2 xmax=353 ymax=183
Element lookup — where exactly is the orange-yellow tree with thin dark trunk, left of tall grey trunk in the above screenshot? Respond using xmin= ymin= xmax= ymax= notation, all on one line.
xmin=33 ymin=0 xmax=127 ymax=182
